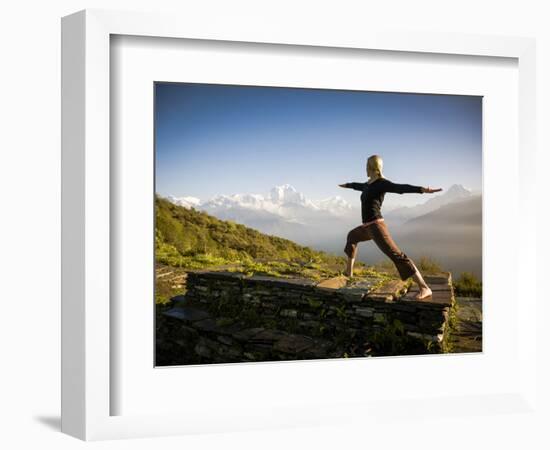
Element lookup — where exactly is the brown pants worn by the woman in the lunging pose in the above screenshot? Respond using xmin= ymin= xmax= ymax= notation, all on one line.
xmin=344 ymin=221 xmax=416 ymax=280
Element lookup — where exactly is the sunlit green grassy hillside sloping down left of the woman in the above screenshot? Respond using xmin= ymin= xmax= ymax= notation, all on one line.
xmin=155 ymin=196 xmax=366 ymax=277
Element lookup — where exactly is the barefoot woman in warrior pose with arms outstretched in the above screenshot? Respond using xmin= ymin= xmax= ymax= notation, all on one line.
xmin=338 ymin=155 xmax=441 ymax=300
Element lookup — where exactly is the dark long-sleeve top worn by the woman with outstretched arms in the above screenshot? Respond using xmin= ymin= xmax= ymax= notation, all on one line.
xmin=344 ymin=178 xmax=422 ymax=223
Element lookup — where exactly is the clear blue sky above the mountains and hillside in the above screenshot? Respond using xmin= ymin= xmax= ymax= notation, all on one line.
xmin=155 ymin=83 xmax=482 ymax=203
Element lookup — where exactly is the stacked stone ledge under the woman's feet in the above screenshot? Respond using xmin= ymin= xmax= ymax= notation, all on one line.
xmin=162 ymin=270 xmax=454 ymax=362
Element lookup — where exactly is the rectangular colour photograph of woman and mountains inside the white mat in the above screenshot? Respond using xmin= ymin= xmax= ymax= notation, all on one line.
xmin=155 ymin=81 xmax=483 ymax=367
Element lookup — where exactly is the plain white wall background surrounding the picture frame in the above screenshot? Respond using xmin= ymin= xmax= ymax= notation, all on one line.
xmin=0 ymin=0 xmax=550 ymax=449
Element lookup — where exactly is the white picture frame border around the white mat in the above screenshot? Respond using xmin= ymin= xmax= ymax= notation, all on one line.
xmin=62 ymin=10 xmax=536 ymax=440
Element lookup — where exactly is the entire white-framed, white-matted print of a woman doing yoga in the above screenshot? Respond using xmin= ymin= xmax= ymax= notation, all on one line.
xmin=62 ymin=11 xmax=536 ymax=440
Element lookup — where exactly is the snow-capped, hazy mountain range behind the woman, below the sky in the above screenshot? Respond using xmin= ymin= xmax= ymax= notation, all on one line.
xmin=168 ymin=184 xmax=481 ymax=276
